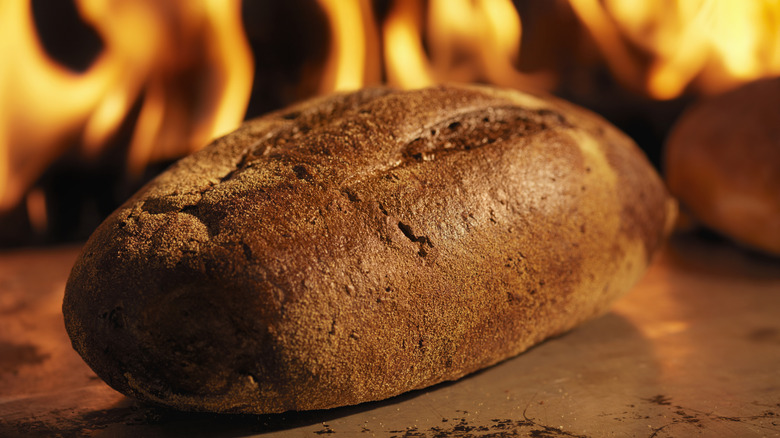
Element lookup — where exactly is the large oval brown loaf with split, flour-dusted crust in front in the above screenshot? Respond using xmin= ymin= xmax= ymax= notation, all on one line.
xmin=63 ymin=86 xmax=675 ymax=413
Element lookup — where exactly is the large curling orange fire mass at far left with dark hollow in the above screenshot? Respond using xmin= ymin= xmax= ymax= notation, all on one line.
xmin=0 ymin=0 xmax=253 ymax=212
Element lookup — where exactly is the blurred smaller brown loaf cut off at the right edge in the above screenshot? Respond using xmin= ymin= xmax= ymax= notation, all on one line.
xmin=664 ymin=77 xmax=780 ymax=256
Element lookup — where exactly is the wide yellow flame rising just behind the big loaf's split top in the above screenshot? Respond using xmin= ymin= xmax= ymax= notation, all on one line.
xmin=384 ymin=0 xmax=553 ymax=89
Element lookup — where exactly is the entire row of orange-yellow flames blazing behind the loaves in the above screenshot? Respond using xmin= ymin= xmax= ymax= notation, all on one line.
xmin=0 ymin=0 xmax=780 ymax=240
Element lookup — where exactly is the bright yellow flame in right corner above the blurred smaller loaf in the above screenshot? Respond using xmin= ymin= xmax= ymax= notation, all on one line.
xmin=570 ymin=0 xmax=780 ymax=99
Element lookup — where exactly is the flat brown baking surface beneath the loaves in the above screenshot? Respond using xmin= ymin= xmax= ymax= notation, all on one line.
xmin=0 ymin=236 xmax=780 ymax=437
